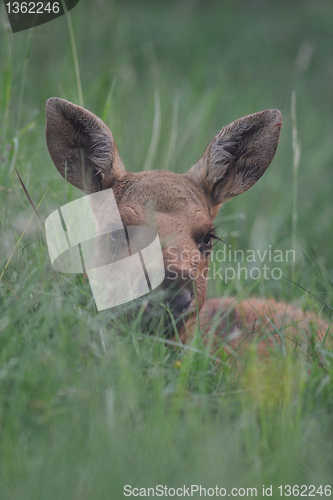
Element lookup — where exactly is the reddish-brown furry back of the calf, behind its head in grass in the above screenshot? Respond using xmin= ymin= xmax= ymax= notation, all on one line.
xmin=200 ymin=297 xmax=330 ymax=357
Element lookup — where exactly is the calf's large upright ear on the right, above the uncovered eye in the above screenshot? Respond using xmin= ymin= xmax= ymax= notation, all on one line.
xmin=187 ymin=109 xmax=282 ymax=207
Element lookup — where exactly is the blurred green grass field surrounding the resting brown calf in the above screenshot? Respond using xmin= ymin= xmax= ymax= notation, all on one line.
xmin=0 ymin=0 xmax=333 ymax=500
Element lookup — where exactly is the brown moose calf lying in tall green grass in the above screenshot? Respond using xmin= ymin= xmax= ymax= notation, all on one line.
xmin=46 ymin=97 xmax=327 ymax=351
